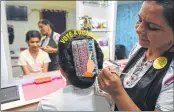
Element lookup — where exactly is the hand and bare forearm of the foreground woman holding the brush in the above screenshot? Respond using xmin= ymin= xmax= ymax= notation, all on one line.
xmin=98 ymin=67 xmax=140 ymax=111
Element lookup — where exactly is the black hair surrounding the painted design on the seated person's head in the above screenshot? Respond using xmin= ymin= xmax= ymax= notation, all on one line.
xmin=58 ymin=30 xmax=103 ymax=89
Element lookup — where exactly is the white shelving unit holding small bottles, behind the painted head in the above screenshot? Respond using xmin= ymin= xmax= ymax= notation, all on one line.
xmin=76 ymin=1 xmax=117 ymax=60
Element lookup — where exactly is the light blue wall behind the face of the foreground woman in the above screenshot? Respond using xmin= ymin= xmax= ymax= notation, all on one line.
xmin=116 ymin=2 xmax=142 ymax=55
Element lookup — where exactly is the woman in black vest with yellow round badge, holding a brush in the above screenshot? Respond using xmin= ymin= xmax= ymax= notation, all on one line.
xmin=98 ymin=0 xmax=174 ymax=111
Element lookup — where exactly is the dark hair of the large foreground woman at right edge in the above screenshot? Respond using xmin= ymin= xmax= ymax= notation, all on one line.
xmin=146 ymin=0 xmax=174 ymax=31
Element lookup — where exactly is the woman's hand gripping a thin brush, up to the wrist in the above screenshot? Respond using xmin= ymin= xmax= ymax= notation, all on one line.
xmin=98 ymin=66 xmax=123 ymax=97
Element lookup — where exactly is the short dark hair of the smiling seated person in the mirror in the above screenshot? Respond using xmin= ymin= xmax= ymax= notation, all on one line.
xmin=26 ymin=30 xmax=41 ymax=42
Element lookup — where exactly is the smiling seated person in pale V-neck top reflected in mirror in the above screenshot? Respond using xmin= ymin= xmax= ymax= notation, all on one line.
xmin=18 ymin=30 xmax=51 ymax=75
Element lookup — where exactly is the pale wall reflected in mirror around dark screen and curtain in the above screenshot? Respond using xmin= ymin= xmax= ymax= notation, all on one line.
xmin=7 ymin=1 xmax=76 ymax=50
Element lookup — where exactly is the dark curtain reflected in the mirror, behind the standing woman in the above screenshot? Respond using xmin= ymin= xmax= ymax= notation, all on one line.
xmin=41 ymin=9 xmax=66 ymax=34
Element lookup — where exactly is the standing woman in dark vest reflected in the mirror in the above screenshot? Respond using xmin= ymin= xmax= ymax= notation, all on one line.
xmin=38 ymin=19 xmax=60 ymax=71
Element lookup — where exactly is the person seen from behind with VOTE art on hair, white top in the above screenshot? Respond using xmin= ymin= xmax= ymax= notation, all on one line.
xmin=37 ymin=30 xmax=114 ymax=111
